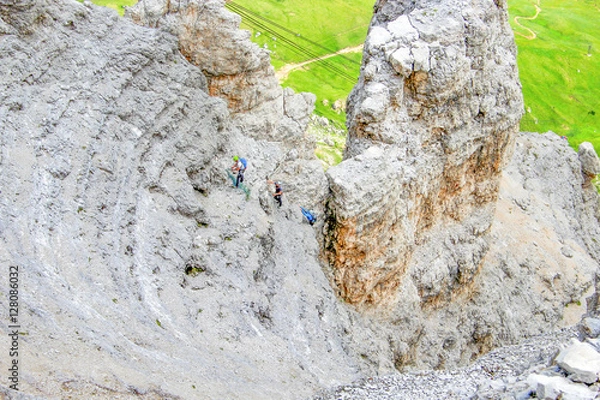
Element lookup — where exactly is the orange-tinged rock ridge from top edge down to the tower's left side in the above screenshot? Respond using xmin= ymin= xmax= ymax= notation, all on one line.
xmin=126 ymin=0 xmax=327 ymax=215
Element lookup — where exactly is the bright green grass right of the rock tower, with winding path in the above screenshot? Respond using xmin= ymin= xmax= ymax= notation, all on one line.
xmin=509 ymin=0 xmax=600 ymax=153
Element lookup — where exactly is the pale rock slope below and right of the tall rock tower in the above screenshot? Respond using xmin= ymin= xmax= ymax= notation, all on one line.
xmin=332 ymin=133 xmax=600 ymax=373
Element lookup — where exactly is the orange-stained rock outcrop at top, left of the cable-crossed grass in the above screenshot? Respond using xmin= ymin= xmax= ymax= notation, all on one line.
xmin=127 ymin=0 xmax=315 ymax=144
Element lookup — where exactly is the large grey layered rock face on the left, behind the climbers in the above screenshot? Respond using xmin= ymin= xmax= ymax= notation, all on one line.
xmin=0 ymin=0 xmax=358 ymax=399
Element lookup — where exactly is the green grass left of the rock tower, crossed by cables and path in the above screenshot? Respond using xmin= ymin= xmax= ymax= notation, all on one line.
xmin=229 ymin=0 xmax=374 ymax=127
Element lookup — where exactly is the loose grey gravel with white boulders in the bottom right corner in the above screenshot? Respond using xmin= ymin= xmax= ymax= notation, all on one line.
xmin=312 ymin=329 xmax=600 ymax=400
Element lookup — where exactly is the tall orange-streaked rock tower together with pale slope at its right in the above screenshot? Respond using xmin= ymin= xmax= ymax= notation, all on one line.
xmin=326 ymin=1 xmax=598 ymax=376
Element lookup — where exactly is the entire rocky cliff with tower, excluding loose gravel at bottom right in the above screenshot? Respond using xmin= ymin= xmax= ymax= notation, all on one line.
xmin=0 ymin=0 xmax=600 ymax=399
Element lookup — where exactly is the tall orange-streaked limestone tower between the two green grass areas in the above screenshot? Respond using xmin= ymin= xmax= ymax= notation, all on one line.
xmin=327 ymin=0 xmax=522 ymax=305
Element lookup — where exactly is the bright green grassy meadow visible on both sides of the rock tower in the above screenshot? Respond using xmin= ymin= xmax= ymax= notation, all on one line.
xmin=237 ymin=0 xmax=600 ymax=153
